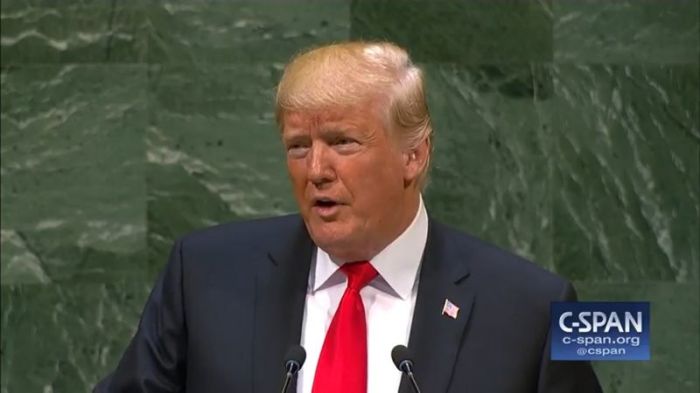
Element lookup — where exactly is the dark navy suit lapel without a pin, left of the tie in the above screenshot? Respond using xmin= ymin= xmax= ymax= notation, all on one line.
xmin=253 ymin=219 xmax=313 ymax=393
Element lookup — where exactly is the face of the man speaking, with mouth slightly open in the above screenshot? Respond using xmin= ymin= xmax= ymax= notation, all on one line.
xmin=282 ymin=105 xmax=420 ymax=261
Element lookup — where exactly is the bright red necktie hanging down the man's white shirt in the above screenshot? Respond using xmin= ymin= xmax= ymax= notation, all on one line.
xmin=311 ymin=261 xmax=377 ymax=393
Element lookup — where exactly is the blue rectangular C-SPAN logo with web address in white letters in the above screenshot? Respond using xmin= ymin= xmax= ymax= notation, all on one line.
xmin=550 ymin=302 xmax=650 ymax=360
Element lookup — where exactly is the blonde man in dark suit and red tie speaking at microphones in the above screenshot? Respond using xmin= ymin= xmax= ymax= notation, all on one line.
xmin=96 ymin=42 xmax=601 ymax=393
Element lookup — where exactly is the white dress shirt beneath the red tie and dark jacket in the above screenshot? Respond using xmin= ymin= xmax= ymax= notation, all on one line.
xmin=297 ymin=197 xmax=428 ymax=393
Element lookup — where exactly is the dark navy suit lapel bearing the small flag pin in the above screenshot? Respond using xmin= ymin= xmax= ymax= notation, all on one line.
xmin=399 ymin=220 xmax=474 ymax=393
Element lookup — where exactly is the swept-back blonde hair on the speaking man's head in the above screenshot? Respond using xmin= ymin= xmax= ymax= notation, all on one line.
xmin=275 ymin=41 xmax=433 ymax=186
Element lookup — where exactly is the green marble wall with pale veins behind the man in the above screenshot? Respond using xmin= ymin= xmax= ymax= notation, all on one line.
xmin=0 ymin=0 xmax=700 ymax=393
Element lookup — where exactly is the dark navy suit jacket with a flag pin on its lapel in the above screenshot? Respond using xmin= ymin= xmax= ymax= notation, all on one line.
xmin=95 ymin=215 xmax=601 ymax=393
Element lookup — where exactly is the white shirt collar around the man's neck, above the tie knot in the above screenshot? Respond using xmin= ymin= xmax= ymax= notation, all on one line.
xmin=309 ymin=196 xmax=428 ymax=299
